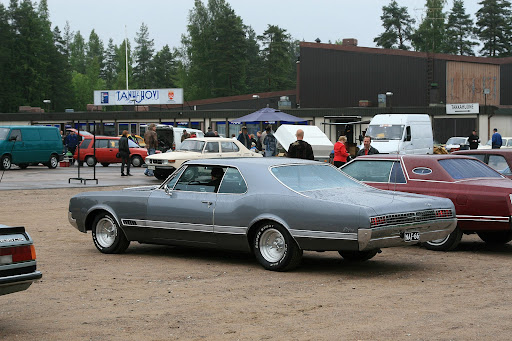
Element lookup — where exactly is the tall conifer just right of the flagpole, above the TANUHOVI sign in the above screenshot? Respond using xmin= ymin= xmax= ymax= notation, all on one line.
xmin=133 ymin=23 xmax=155 ymax=89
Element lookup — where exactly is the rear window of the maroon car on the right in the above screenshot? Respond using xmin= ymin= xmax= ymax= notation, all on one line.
xmin=439 ymin=159 xmax=502 ymax=180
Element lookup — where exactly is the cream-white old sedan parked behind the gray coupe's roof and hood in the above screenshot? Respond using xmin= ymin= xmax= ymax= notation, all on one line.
xmin=146 ymin=137 xmax=263 ymax=180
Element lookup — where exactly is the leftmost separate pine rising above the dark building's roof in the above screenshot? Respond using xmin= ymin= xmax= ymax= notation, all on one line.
xmin=373 ymin=0 xmax=415 ymax=50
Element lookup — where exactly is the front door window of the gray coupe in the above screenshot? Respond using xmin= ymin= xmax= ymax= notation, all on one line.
xmin=174 ymin=165 xmax=226 ymax=192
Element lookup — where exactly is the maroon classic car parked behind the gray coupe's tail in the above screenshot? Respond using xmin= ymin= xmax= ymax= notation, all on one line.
xmin=341 ymin=154 xmax=512 ymax=251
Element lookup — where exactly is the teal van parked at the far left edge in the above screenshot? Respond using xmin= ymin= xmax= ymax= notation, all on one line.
xmin=0 ymin=126 xmax=64 ymax=169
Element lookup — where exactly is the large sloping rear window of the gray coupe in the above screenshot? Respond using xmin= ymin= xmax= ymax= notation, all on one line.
xmin=271 ymin=165 xmax=363 ymax=192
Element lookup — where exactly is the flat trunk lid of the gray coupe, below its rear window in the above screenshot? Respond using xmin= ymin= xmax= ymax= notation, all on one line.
xmin=302 ymin=186 xmax=450 ymax=215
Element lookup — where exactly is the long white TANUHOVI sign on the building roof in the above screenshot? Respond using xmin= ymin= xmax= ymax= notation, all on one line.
xmin=94 ymin=89 xmax=183 ymax=105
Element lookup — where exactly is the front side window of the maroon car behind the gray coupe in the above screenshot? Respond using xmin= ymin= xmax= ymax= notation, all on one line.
xmin=341 ymin=160 xmax=394 ymax=182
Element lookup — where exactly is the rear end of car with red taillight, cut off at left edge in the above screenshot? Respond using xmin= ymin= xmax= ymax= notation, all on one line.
xmin=0 ymin=225 xmax=43 ymax=295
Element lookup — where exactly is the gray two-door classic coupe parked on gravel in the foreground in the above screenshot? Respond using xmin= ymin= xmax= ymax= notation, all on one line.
xmin=69 ymin=158 xmax=456 ymax=271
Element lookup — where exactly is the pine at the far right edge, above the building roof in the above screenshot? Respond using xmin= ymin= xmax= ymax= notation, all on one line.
xmin=476 ymin=0 xmax=512 ymax=57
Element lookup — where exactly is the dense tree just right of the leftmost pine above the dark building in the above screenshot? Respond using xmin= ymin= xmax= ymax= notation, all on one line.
xmin=412 ymin=0 xmax=446 ymax=52
